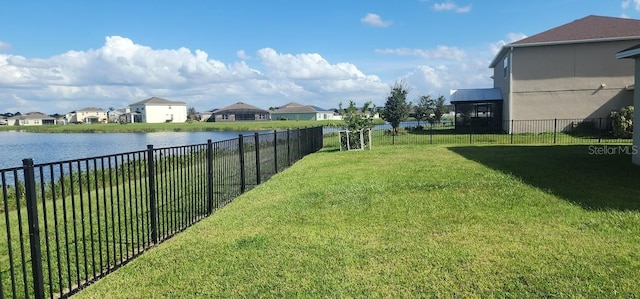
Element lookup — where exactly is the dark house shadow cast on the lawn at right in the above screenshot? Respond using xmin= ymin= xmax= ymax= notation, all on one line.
xmin=449 ymin=145 xmax=640 ymax=211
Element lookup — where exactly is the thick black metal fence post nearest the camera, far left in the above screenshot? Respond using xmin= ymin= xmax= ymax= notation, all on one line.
xmin=22 ymin=159 xmax=46 ymax=298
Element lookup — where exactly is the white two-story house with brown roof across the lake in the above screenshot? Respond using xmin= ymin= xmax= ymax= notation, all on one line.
xmin=126 ymin=97 xmax=187 ymax=123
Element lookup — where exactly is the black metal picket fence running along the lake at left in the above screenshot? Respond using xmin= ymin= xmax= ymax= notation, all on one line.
xmin=0 ymin=127 xmax=323 ymax=298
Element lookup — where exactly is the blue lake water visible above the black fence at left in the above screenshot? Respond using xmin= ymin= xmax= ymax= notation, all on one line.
xmin=0 ymin=131 xmax=266 ymax=169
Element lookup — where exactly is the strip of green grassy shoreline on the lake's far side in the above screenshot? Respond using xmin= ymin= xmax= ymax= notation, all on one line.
xmin=0 ymin=120 xmax=350 ymax=133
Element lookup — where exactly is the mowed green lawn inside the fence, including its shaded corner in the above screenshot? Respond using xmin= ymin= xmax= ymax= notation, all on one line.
xmin=76 ymin=145 xmax=640 ymax=298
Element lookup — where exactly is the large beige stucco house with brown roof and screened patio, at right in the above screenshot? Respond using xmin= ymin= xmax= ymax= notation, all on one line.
xmin=450 ymin=16 xmax=640 ymax=132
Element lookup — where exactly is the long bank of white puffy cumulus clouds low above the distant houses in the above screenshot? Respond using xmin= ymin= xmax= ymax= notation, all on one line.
xmin=0 ymin=36 xmax=387 ymax=113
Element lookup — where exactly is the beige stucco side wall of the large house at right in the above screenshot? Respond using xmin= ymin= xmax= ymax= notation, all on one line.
xmin=508 ymin=40 xmax=640 ymax=120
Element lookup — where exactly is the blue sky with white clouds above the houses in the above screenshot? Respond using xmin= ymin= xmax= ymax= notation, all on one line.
xmin=0 ymin=0 xmax=640 ymax=114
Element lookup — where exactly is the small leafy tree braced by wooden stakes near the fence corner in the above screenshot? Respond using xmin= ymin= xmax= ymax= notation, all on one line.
xmin=338 ymin=101 xmax=375 ymax=149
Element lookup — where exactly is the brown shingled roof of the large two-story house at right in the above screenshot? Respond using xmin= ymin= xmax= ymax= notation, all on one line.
xmin=489 ymin=15 xmax=640 ymax=68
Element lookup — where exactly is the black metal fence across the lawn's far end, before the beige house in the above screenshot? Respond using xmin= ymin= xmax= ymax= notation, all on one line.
xmin=325 ymin=118 xmax=632 ymax=147
